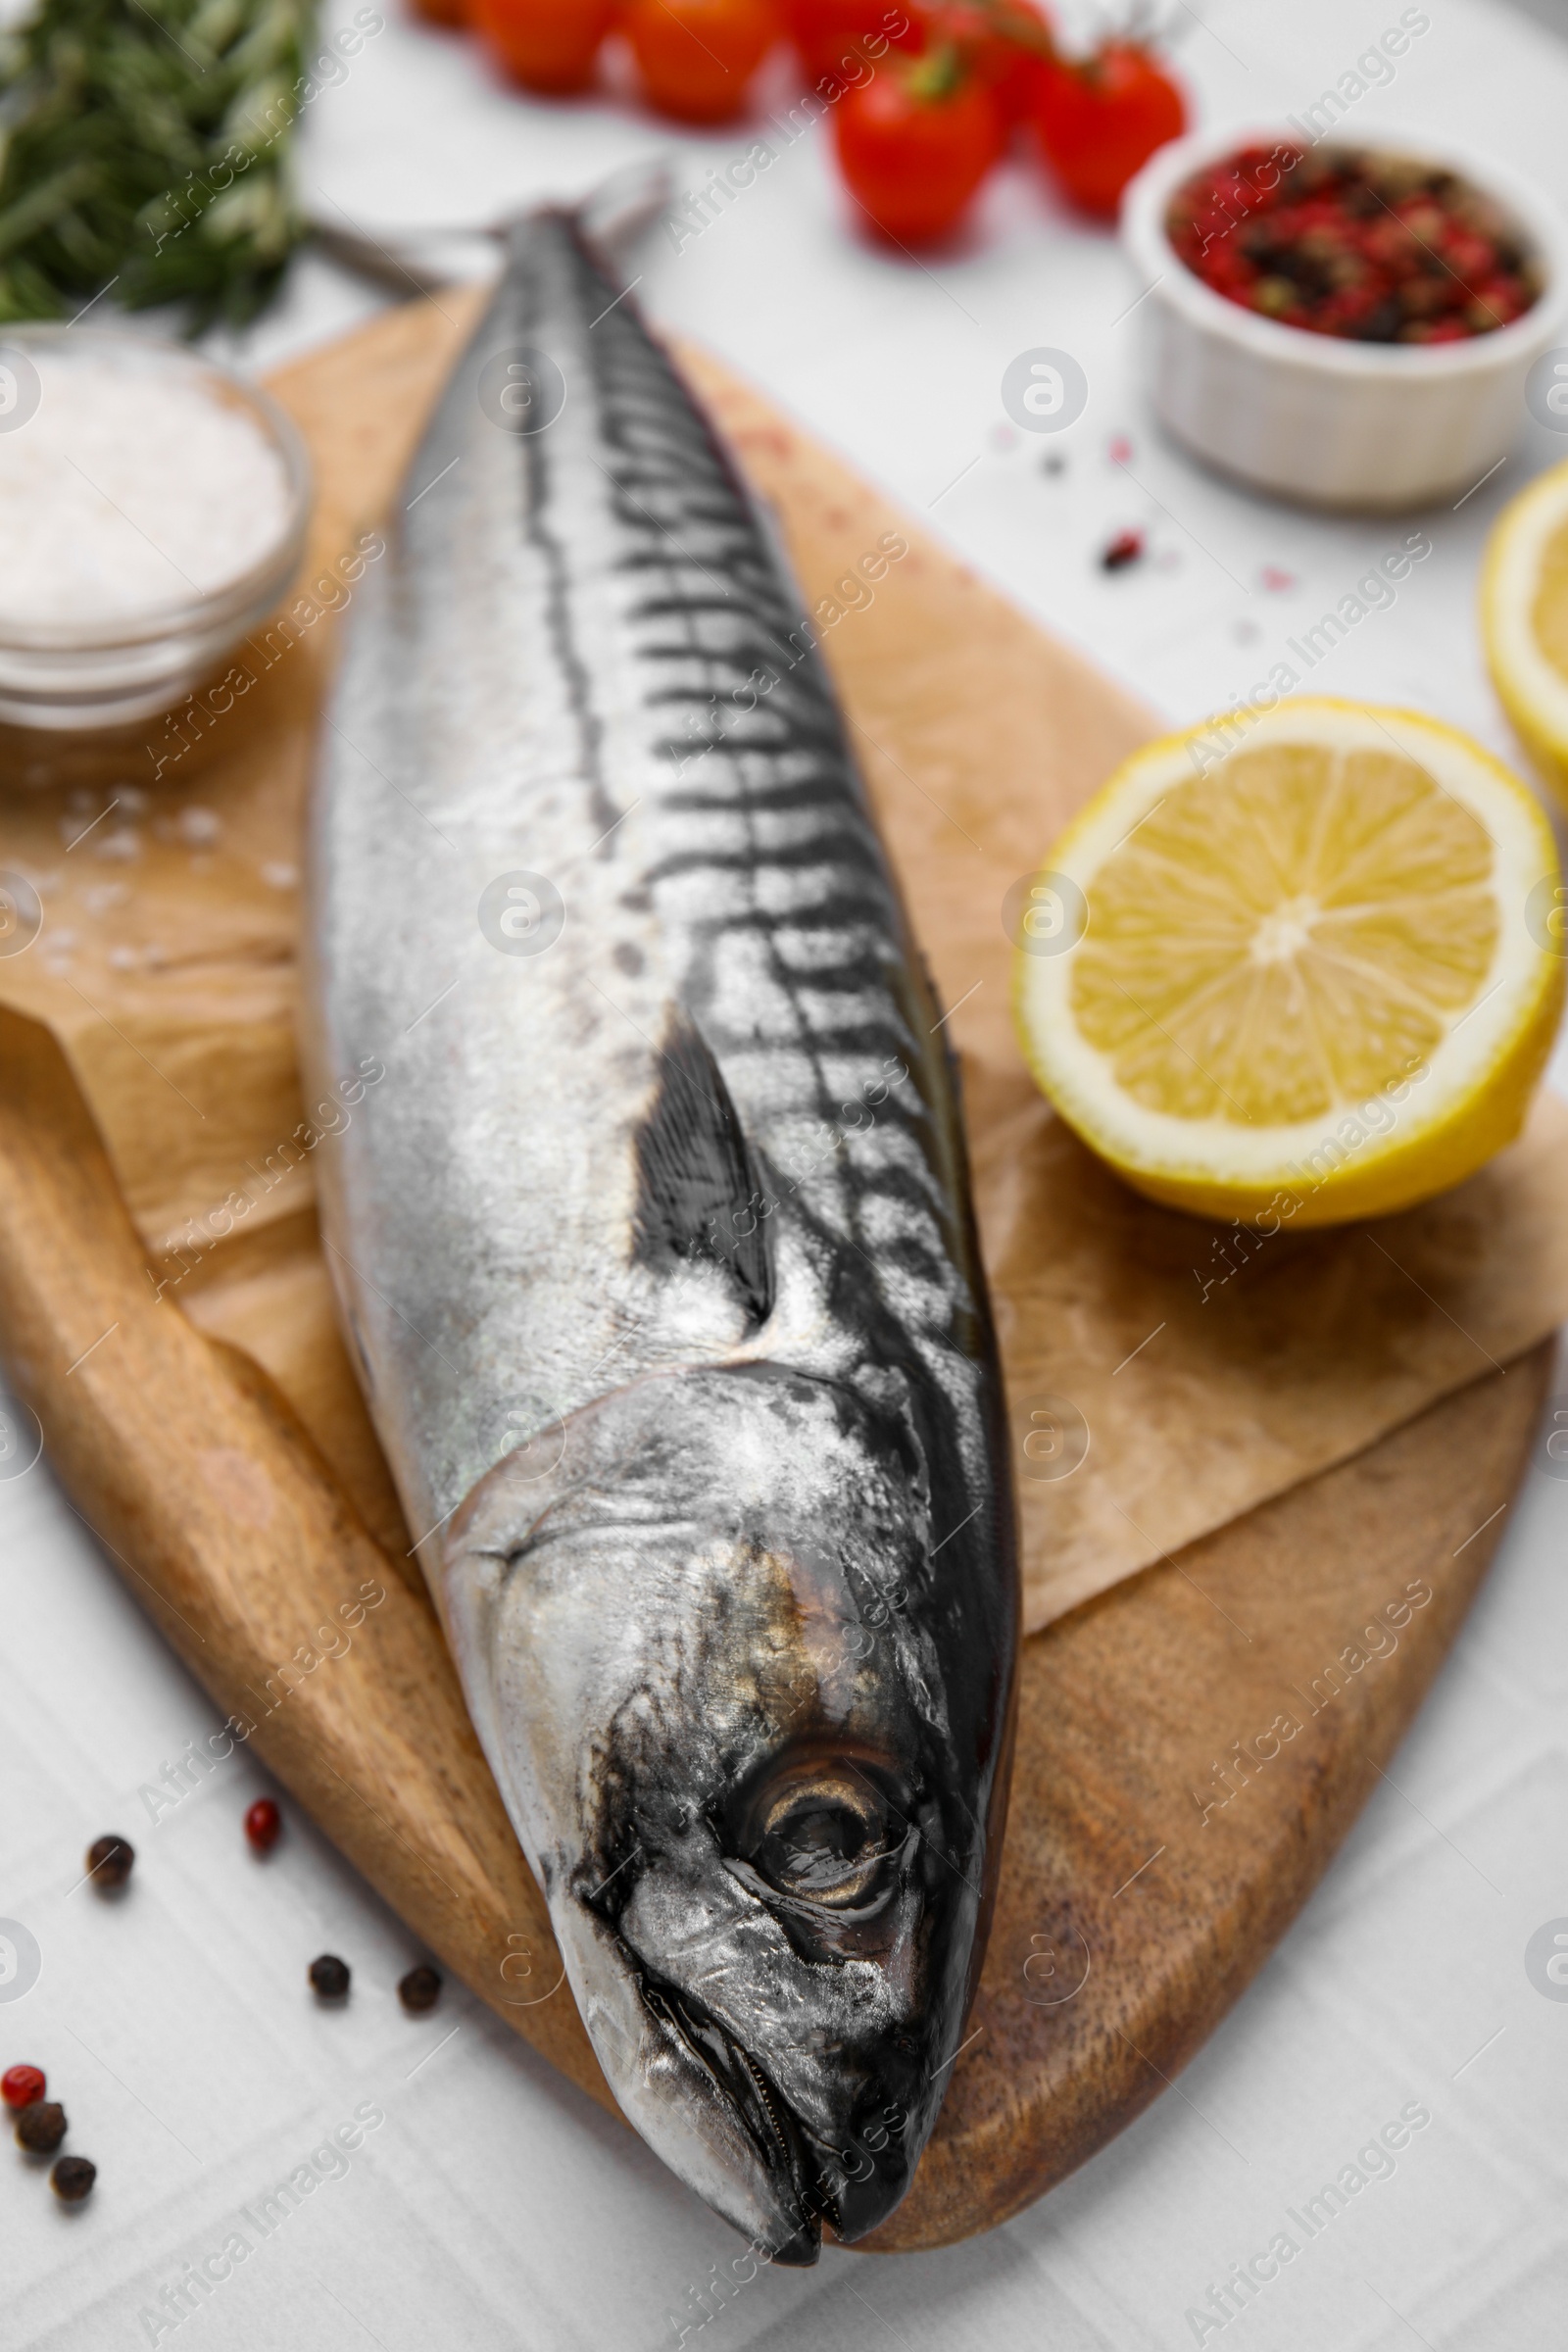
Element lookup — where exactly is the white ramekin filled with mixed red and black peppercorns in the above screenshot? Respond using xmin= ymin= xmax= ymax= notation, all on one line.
xmin=1121 ymin=127 xmax=1568 ymax=511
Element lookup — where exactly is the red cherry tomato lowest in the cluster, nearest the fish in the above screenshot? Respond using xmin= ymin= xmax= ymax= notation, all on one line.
xmin=832 ymin=49 xmax=1004 ymax=245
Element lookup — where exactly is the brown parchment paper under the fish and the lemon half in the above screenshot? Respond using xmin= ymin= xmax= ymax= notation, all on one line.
xmin=0 ymin=296 xmax=1568 ymax=1630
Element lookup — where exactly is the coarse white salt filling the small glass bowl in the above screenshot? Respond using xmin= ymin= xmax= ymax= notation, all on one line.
xmin=0 ymin=336 xmax=289 ymax=628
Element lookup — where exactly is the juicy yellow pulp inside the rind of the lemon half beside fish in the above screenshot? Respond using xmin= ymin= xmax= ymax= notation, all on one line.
xmin=1072 ymin=743 xmax=1497 ymax=1127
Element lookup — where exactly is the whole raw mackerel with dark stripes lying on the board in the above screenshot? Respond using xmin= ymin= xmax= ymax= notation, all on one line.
xmin=306 ymin=212 xmax=1015 ymax=2260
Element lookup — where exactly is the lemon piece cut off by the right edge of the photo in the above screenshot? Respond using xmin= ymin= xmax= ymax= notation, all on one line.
xmin=1481 ymin=464 xmax=1568 ymax=802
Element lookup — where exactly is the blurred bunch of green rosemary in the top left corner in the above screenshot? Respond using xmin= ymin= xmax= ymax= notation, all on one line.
xmin=0 ymin=0 xmax=313 ymax=327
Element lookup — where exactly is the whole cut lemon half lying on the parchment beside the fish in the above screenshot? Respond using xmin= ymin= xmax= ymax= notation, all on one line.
xmin=1013 ymin=696 xmax=1568 ymax=1230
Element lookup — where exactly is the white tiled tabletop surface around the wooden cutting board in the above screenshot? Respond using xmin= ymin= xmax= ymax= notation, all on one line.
xmin=0 ymin=0 xmax=1568 ymax=2352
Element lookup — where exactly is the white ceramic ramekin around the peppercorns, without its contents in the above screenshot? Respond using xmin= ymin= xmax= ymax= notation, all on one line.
xmin=1121 ymin=120 xmax=1568 ymax=511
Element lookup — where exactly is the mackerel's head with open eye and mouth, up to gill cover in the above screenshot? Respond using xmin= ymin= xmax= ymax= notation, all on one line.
xmin=447 ymin=1364 xmax=1006 ymax=2263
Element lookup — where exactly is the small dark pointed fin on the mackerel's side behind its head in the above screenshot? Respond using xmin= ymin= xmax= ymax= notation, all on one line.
xmin=635 ymin=1013 xmax=773 ymax=1324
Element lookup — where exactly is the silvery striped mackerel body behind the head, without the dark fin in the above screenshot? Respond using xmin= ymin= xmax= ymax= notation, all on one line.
xmin=313 ymin=217 xmax=985 ymax=1561
